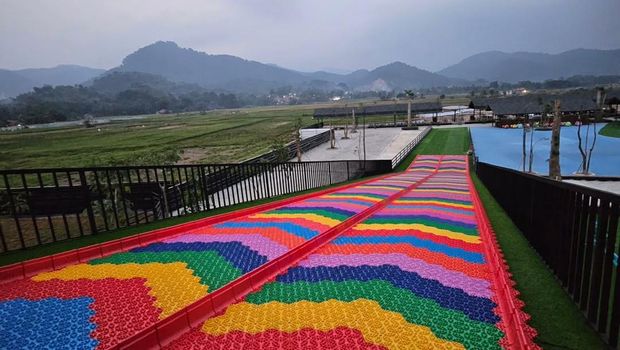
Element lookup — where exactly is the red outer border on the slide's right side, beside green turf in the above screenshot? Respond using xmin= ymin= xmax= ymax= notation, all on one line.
xmin=466 ymin=162 xmax=541 ymax=349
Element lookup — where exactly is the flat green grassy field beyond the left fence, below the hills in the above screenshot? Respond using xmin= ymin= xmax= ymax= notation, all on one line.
xmin=0 ymin=99 xmax=463 ymax=169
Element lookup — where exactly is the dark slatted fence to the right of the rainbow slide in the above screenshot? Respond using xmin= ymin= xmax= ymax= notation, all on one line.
xmin=476 ymin=163 xmax=620 ymax=348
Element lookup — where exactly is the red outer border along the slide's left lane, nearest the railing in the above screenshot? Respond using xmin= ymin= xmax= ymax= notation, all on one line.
xmin=0 ymin=173 xmax=393 ymax=284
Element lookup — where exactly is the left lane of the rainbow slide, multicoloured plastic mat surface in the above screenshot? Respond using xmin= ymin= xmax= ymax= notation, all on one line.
xmin=0 ymin=163 xmax=432 ymax=349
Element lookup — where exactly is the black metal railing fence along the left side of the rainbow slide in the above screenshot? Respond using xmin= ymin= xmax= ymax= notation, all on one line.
xmin=0 ymin=160 xmax=391 ymax=252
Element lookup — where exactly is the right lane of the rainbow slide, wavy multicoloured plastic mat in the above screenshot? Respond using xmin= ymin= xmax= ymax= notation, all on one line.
xmin=169 ymin=156 xmax=528 ymax=350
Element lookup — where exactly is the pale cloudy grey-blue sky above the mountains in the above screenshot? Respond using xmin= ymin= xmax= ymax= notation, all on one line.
xmin=0 ymin=0 xmax=620 ymax=71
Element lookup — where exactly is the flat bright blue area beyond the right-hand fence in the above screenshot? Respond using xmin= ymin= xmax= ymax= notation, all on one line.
xmin=471 ymin=124 xmax=620 ymax=176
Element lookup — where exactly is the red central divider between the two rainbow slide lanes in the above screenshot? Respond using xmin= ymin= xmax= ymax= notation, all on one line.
xmin=113 ymin=163 xmax=436 ymax=350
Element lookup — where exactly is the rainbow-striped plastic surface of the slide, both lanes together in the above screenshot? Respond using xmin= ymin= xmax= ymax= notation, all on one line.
xmin=0 ymin=156 xmax=532 ymax=350
